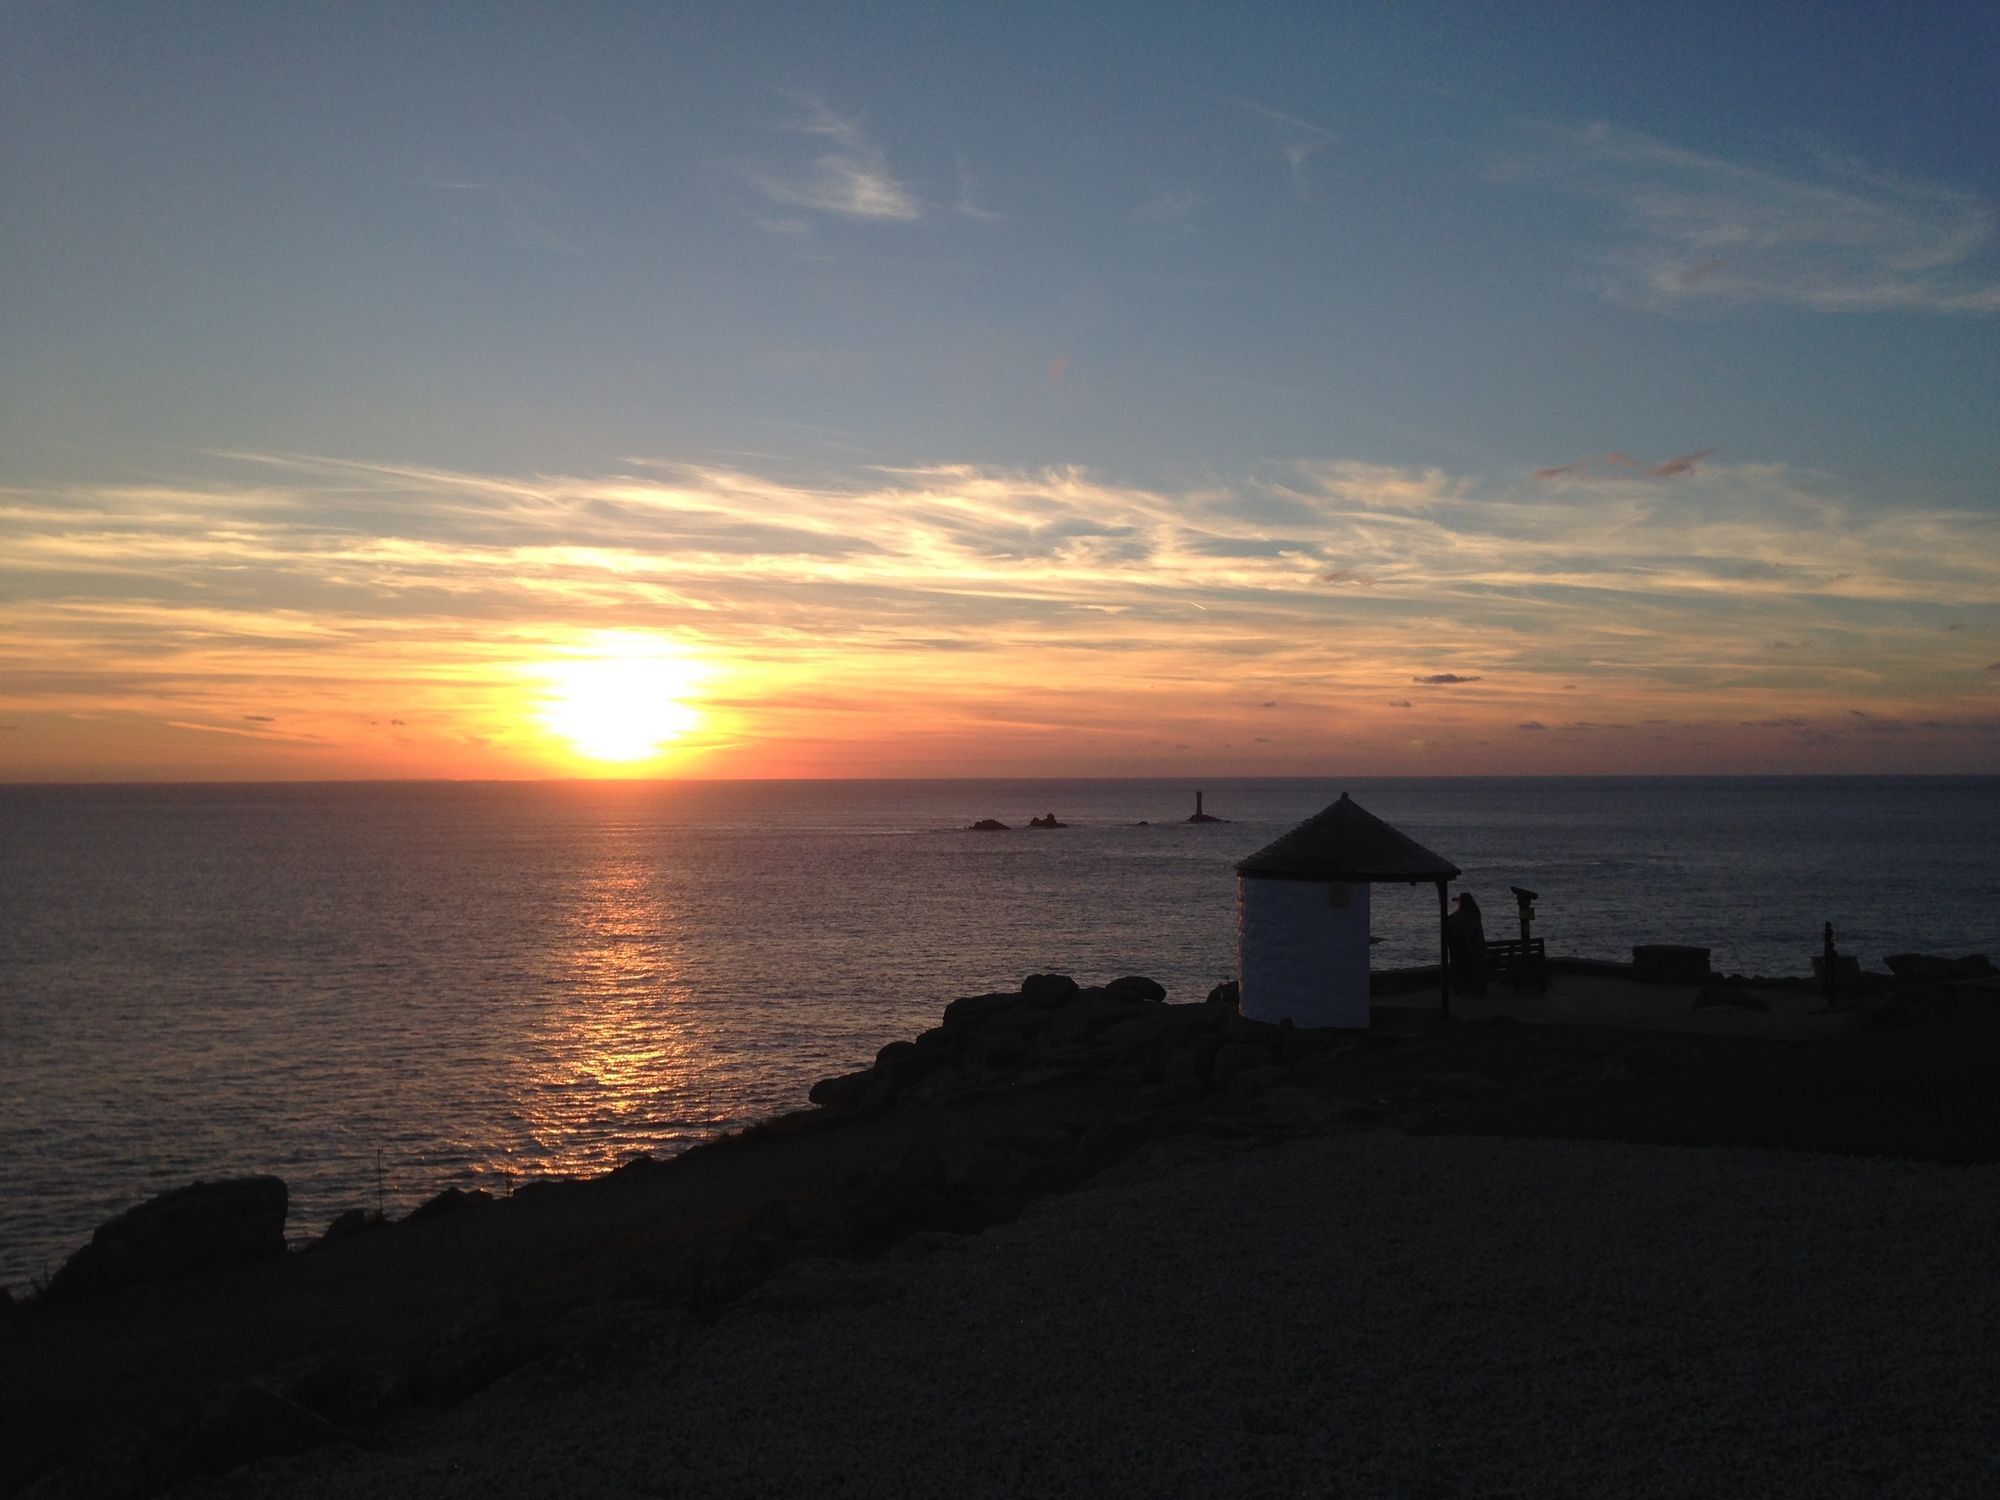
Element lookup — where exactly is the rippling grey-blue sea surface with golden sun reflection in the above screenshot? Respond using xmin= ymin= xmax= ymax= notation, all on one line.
xmin=0 ymin=778 xmax=2000 ymax=1288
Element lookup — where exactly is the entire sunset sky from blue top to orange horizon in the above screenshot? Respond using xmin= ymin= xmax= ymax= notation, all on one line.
xmin=0 ymin=0 xmax=2000 ymax=780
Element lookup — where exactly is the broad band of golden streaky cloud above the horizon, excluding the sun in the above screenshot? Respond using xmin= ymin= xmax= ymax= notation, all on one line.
xmin=0 ymin=454 xmax=2000 ymax=764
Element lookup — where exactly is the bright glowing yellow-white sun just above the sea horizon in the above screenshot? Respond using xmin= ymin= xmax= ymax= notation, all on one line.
xmin=536 ymin=632 xmax=704 ymax=764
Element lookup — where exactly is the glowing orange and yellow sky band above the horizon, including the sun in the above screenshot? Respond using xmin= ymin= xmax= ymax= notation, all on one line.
xmin=0 ymin=456 xmax=2000 ymax=780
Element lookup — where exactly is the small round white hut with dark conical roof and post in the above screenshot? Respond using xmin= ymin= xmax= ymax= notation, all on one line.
xmin=1236 ymin=792 xmax=1458 ymax=1028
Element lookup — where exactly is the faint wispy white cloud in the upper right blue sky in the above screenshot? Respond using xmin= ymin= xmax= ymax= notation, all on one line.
xmin=1492 ymin=122 xmax=2000 ymax=314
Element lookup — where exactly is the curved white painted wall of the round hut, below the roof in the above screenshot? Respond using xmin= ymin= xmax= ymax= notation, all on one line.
xmin=1236 ymin=876 xmax=1370 ymax=1028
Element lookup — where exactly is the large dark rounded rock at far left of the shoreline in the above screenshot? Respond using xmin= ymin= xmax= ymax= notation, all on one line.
xmin=48 ymin=1176 xmax=288 ymax=1296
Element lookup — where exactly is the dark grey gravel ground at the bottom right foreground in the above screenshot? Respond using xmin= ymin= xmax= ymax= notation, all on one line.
xmin=211 ymin=1132 xmax=2000 ymax=1496
